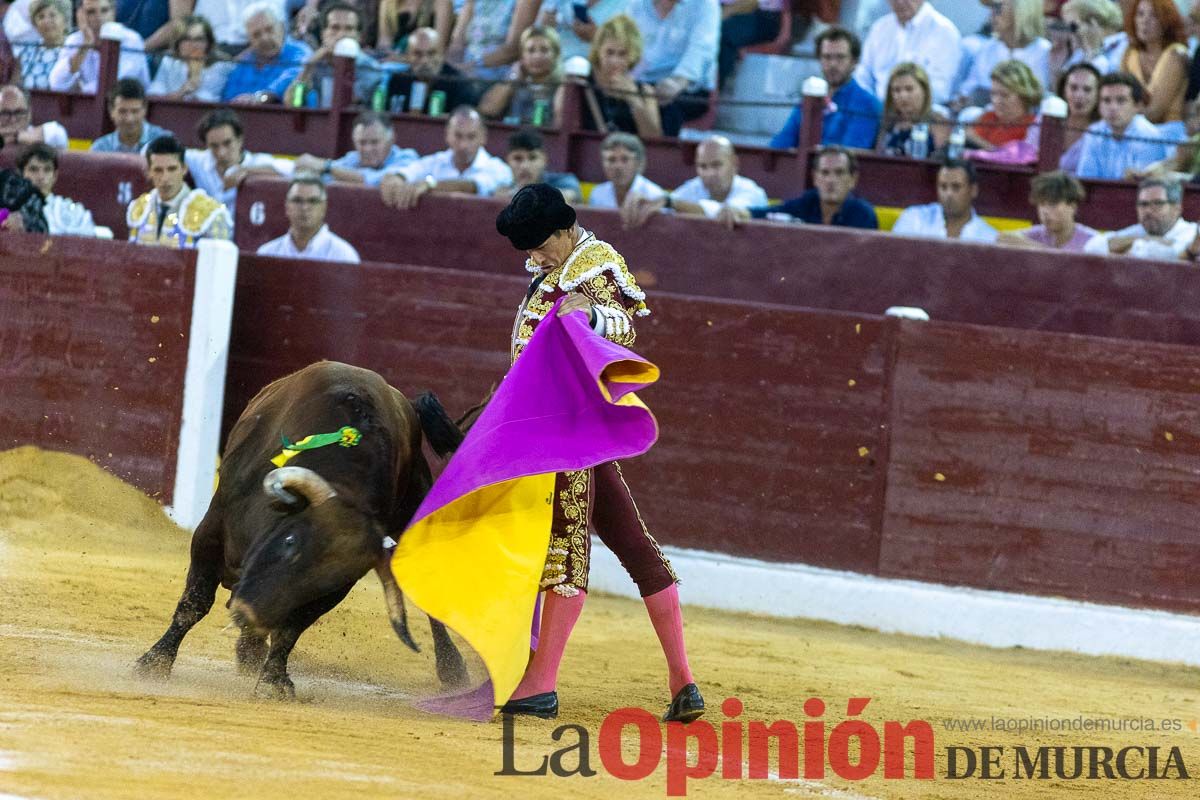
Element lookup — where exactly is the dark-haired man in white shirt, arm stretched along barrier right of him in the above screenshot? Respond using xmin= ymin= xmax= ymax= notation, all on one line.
xmin=184 ymin=108 xmax=293 ymax=217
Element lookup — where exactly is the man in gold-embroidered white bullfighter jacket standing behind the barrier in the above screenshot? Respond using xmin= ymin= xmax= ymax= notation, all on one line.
xmin=125 ymin=136 xmax=233 ymax=248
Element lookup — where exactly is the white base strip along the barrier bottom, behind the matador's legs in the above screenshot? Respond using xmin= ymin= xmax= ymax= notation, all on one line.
xmin=589 ymin=536 xmax=1200 ymax=666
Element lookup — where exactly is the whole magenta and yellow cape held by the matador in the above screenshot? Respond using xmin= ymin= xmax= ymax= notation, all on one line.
xmin=391 ymin=306 xmax=659 ymax=720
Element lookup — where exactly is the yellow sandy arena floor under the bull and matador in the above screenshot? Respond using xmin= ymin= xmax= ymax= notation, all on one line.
xmin=0 ymin=449 xmax=1200 ymax=800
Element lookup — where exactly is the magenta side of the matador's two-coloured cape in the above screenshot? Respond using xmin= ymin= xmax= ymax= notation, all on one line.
xmin=413 ymin=301 xmax=658 ymax=523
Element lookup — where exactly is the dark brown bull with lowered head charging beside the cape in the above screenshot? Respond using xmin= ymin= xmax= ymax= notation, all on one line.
xmin=136 ymin=361 xmax=467 ymax=698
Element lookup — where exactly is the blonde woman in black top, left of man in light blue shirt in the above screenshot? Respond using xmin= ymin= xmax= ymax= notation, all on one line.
xmin=580 ymin=14 xmax=662 ymax=138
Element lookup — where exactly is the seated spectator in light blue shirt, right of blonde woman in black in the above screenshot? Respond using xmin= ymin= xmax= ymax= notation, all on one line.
xmin=629 ymin=0 xmax=721 ymax=136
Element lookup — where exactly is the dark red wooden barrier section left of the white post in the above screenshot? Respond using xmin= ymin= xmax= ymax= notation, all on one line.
xmin=0 ymin=235 xmax=196 ymax=500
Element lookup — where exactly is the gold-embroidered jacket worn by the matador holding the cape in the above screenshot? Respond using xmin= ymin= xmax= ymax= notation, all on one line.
xmin=511 ymin=233 xmax=650 ymax=361
